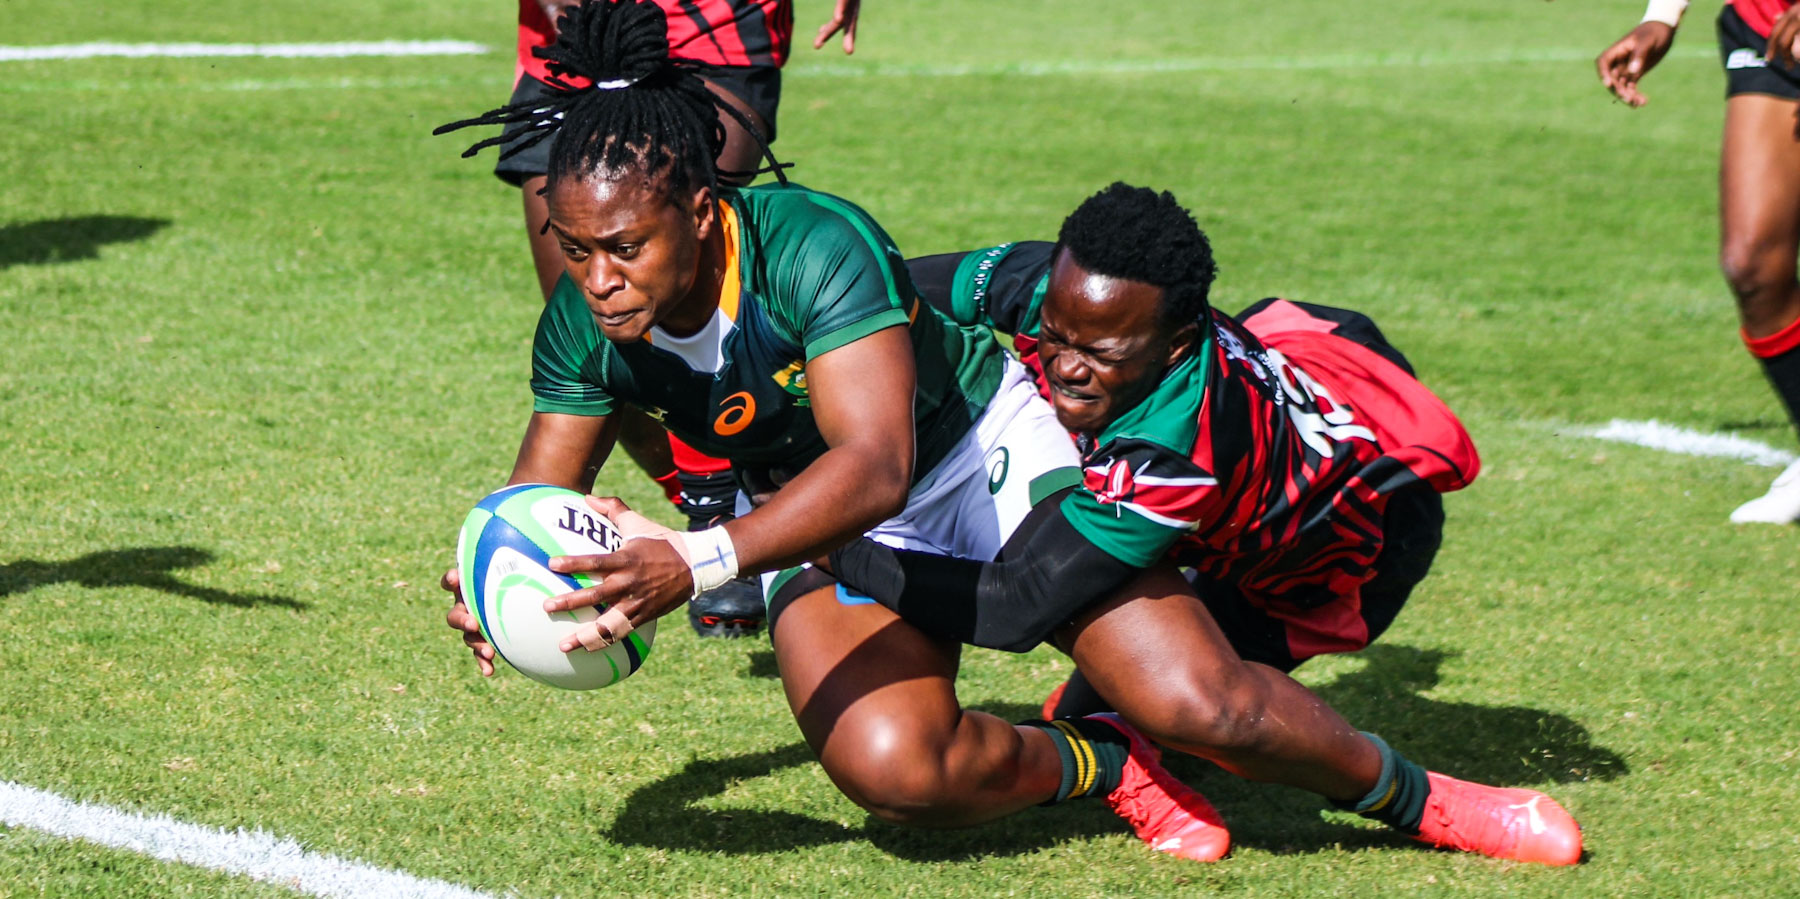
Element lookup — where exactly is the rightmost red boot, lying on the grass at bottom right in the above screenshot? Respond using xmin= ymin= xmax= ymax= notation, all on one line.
xmin=1413 ymin=771 xmax=1580 ymax=865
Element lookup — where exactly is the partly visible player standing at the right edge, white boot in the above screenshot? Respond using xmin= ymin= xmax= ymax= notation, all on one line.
xmin=1595 ymin=0 xmax=1800 ymax=524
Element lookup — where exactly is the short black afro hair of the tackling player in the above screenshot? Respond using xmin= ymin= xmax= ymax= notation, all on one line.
xmin=1057 ymin=182 xmax=1219 ymax=330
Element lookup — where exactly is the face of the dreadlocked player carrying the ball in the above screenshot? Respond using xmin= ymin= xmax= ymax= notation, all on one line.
xmin=547 ymin=173 xmax=713 ymax=344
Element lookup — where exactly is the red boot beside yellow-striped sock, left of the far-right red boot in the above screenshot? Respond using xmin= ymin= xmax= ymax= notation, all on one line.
xmin=1085 ymin=712 xmax=1231 ymax=861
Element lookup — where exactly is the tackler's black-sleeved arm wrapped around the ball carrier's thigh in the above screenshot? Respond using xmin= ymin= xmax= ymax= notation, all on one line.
xmin=830 ymin=490 xmax=1138 ymax=652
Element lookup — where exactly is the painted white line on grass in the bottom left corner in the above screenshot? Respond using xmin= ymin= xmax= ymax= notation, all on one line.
xmin=0 ymin=780 xmax=493 ymax=899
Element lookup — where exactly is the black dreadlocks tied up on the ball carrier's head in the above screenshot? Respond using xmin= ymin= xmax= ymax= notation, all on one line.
xmin=432 ymin=0 xmax=787 ymax=196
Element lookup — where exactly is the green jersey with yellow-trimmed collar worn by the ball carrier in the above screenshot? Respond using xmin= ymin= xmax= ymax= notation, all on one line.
xmin=531 ymin=184 xmax=1003 ymax=483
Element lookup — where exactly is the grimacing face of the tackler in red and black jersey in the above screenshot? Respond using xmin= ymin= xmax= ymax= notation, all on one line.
xmin=1037 ymin=250 xmax=1195 ymax=434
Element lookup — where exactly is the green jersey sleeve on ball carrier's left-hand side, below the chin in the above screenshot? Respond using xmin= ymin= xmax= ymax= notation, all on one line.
xmin=531 ymin=276 xmax=616 ymax=416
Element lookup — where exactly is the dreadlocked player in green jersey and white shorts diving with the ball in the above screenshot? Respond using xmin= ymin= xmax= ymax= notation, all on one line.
xmin=430 ymin=0 xmax=1224 ymax=858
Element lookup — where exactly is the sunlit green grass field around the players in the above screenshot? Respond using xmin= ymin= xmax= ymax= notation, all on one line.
xmin=0 ymin=0 xmax=1800 ymax=897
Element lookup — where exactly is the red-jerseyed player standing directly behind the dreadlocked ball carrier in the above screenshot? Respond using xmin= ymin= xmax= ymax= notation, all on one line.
xmin=493 ymin=0 xmax=862 ymax=636
